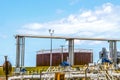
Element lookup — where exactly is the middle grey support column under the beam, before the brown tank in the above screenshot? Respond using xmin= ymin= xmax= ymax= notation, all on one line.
xmin=68 ymin=39 xmax=74 ymax=65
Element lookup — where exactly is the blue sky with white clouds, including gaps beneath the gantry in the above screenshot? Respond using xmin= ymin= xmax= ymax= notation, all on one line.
xmin=0 ymin=0 xmax=120 ymax=66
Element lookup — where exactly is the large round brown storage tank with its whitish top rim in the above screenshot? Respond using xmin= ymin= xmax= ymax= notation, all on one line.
xmin=36 ymin=49 xmax=93 ymax=66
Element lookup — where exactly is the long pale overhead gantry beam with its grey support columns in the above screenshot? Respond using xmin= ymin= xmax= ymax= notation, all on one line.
xmin=15 ymin=34 xmax=120 ymax=68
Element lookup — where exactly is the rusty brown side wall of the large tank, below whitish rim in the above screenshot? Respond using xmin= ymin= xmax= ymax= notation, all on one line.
xmin=36 ymin=52 xmax=93 ymax=66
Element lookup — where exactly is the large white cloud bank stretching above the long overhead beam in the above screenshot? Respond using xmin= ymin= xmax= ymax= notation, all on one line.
xmin=19 ymin=3 xmax=120 ymax=43
